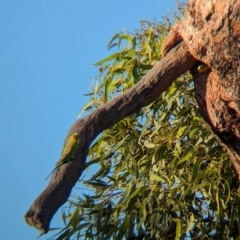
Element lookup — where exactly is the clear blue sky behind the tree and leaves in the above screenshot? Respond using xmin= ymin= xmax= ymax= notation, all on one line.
xmin=0 ymin=0 xmax=176 ymax=240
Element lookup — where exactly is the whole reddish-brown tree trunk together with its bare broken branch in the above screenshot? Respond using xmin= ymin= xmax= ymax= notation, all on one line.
xmin=25 ymin=0 xmax=240 ymax=233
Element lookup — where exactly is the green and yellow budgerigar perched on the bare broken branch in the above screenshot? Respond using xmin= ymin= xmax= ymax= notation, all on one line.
xmin=46 ymin=133 xmax=79 ymax=179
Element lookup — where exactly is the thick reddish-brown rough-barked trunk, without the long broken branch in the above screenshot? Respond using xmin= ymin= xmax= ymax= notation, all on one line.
xmin=162 ymin=0 xmax=240 ymax=176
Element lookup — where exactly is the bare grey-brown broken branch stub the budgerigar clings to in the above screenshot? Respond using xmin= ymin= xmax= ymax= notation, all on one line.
xmin=25 ymin=43 xmax=197 ymax=233
